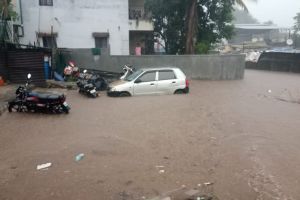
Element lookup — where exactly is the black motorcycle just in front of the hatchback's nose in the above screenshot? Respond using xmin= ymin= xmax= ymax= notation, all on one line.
xmin=77 ymin=70 xmax=108 ymax=98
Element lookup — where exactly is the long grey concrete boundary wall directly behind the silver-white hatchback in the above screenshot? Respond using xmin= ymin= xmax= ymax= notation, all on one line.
xmin=65 ymin=49 xmax=245 ymax=80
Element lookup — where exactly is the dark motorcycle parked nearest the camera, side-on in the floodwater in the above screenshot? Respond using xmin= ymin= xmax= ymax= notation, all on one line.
xmin=8 ymin=74 xmax=70 ymax=114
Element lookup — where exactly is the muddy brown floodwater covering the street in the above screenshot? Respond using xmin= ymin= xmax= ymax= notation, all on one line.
xmin=0 ymin=70 xmax=300 ymax=200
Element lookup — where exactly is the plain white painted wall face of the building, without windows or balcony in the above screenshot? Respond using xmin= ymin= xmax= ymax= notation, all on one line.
xmin=20 ymin=0 xmax=129 ymax=55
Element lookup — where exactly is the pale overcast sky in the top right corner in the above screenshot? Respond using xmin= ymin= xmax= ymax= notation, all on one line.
xmin=244 ymin=0 xmax=300 ymax=28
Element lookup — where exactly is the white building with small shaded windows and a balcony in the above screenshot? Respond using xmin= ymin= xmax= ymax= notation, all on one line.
xmin=15 ymin=0 xmax=153 ymax=55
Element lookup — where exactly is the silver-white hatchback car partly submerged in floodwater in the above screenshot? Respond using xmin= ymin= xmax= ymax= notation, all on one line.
xmin=107 ymin=67 xmax=189 ymax=96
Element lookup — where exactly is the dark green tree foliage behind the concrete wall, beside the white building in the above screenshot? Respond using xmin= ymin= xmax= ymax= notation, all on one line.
xmin=146 ymin=0 xmax=235 ymax=54
